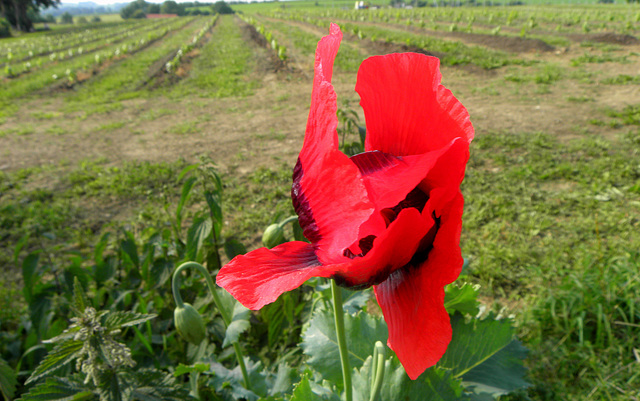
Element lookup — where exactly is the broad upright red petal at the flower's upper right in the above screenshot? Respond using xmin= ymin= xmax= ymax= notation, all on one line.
xmin=356 ymin=53 xmax=473 ymax=156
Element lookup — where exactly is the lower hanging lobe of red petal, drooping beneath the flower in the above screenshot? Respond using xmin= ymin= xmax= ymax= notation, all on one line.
xmin=374 ymin=266 xmax=451 ymax=380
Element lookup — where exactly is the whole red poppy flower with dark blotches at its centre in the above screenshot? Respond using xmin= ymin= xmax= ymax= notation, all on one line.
xmin=217 ymin=24 xmax=473 ymax=379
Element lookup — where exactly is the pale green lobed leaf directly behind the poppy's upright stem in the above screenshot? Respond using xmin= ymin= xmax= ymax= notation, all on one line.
xmin=300 ymin=310 xmax=388 ymax=388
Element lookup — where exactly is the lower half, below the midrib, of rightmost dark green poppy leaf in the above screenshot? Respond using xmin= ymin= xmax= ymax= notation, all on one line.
xmin=462 ymin=340 xmax=530 ymax=398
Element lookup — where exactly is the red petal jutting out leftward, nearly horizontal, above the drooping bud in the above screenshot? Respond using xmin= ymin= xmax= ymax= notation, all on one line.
xmin=216 ymin=241 xmax=333 ymax=310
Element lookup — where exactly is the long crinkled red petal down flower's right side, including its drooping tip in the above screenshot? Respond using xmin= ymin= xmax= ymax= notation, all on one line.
xmin=374 ymin=187 xmax=464 ymax=379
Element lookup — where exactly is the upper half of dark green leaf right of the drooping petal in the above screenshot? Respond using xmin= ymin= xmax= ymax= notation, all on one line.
xmin=438 ymin=313 xmax=513 ymax=377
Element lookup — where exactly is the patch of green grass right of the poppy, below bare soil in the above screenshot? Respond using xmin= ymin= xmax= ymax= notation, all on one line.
xmin=462 ymin=133 xmax=640 ymax=400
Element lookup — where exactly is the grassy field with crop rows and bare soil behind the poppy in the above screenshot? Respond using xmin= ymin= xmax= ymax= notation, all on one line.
xmin=0 ymin=1 xmax=640 ymax=401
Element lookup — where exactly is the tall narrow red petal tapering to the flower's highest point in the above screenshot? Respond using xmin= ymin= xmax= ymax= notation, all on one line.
xmin=291 ymin=24 xmax=375 ymax=264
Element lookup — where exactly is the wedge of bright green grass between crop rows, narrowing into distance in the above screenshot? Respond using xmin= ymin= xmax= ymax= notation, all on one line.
xmin=170 ymin=15 xmax=259 ymax=98
